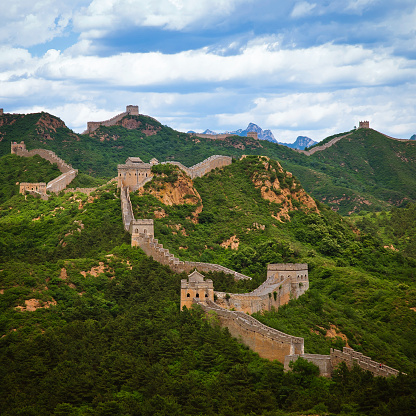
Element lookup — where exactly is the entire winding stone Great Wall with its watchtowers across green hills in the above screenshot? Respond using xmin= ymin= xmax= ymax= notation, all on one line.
xmin=4 ymin=106 xmax=399 ymax=377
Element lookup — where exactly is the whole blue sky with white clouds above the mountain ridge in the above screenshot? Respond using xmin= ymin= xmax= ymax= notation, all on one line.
xmin=0 ymin=0 xmax=416 ymax=142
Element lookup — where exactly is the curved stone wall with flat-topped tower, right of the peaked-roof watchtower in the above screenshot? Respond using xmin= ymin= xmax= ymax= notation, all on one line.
xmin=215 ymin=263 xmax=309 ymax=314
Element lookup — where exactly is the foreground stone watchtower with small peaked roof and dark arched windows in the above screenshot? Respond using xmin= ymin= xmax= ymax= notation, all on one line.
xmin=181 ymin=270 xmax=214 ymax=310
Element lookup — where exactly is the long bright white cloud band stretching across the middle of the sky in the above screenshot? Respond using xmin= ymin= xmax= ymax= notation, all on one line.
xmin=28 ymin=44 xmax=416 ymax=89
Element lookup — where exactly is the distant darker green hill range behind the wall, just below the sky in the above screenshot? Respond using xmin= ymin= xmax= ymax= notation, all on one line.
xmin=0 ymin=113 xmax=416 ymax=214
